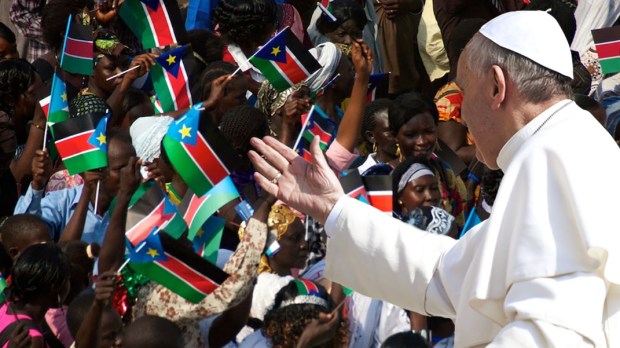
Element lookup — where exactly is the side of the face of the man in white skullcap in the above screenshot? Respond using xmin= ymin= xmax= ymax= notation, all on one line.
xmin=456 ymin=50 xmax=503 ymax=169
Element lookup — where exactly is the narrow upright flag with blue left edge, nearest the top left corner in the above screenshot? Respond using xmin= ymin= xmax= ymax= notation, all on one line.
xmin=60 ymin=15 xmax=93 ymax=75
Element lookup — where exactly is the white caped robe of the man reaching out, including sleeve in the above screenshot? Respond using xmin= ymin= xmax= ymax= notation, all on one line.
xmin=325 ymin=100 xmax=620 ymax=348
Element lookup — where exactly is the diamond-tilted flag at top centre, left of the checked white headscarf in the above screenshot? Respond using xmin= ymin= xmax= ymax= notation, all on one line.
xmin=249 ymin=28 xmax=321 ymax=92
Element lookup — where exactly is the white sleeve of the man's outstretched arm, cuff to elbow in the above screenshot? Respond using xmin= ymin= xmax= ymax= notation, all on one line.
xmin=325 ymin=197 xmax=456 ymax=317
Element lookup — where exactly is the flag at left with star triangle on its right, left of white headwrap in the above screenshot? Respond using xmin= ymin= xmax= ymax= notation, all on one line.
xmin=52 ymin=114 xmax=109 ymax=175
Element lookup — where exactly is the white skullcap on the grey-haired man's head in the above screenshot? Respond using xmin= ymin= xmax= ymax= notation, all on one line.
xmin=480 ymin=11 xmax=573 ymax=79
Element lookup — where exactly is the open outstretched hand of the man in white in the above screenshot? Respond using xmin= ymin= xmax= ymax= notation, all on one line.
xmin=248 ymin=137 xmax=344 ymax=223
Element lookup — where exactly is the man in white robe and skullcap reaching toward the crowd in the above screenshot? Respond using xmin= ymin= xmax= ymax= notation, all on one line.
xmin=250 ymin=11 xmax=620 ymax=348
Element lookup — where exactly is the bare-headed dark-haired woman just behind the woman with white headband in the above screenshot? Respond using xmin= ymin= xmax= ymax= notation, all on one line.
xmin=389 ymin=92 xmax=466 ymax=229
